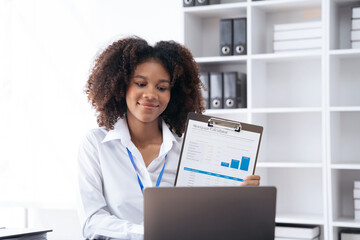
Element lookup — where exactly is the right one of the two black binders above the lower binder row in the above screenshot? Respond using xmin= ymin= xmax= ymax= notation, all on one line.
xmin=233 ymin=18 xmax=247 ymax=55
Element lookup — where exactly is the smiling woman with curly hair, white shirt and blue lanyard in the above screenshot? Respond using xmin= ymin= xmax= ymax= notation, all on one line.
xmin=79 ymin=37 xmax=260 ymax=239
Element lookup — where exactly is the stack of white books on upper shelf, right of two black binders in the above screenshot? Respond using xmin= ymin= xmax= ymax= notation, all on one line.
xmin=274 ymin=21 xmax=322 ymax=52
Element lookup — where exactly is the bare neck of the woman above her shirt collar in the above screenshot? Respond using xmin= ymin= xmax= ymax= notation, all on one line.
xmin=126 ymin=114 xmax=162 ymax=149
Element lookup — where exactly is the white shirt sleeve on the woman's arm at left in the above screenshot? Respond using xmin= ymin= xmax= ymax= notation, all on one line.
xmin=78 ymin=132 xmax=144 ymax=239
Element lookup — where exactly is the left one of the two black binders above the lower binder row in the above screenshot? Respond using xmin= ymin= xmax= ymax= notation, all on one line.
xmin=220 ymin=19 xmax=233 ymax=56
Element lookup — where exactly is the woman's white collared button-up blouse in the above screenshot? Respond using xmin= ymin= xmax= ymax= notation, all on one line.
xmin=78 ymin=119 xmax=182 ymax=239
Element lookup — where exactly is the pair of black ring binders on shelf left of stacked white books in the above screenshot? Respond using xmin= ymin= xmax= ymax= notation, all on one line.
xmin=220 ymin=18 xmax=247 ymax=56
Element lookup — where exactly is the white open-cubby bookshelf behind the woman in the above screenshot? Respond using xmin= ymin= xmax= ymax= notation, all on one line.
xmin=183 ymin=0 xmax=360 ymax=240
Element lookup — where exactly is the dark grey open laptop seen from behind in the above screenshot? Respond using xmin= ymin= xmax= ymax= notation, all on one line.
xmin=144 ymin=186 xmax=276 ymax=240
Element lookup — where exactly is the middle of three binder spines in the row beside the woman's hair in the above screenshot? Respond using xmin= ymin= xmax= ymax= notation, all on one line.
xmin=210 ymin=72 xmax=223 ymax=109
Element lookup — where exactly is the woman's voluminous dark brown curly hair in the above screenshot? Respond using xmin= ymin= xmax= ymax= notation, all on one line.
xmin=85 ymin=37 xmax=205 ymax=136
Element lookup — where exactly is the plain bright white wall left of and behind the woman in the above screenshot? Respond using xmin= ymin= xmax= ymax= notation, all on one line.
xmin=0 ymin=0 xmax=183 ymax=239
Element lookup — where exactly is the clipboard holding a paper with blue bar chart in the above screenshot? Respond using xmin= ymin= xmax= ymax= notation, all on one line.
xmin=175 ymin=112 xmax=263 ymax=187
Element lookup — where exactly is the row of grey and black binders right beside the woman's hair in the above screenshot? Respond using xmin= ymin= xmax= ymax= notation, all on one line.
xmin=200 ymin=72 xmax=246 ymax=109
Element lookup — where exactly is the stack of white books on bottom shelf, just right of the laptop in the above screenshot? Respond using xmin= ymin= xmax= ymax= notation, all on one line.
xmin=275 ymin=223 xmax=320 ymax=240
